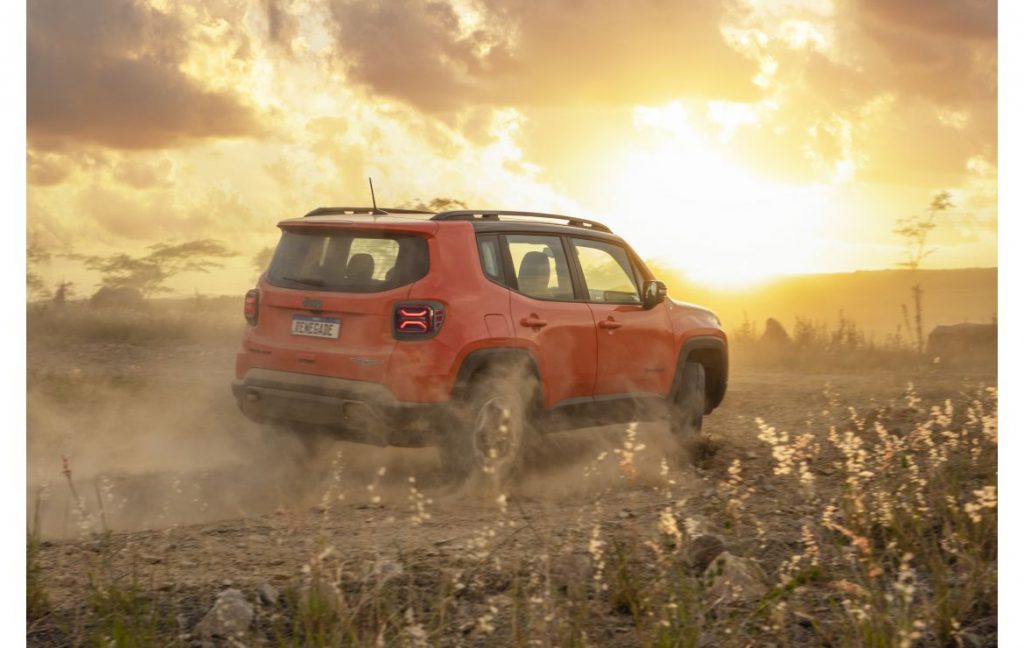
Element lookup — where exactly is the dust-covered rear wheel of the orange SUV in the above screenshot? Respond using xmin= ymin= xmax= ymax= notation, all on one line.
xmin=438 ymin=370 xmax=530 ymax=484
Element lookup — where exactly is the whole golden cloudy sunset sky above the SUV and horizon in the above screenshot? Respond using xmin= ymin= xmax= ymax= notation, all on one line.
xmin=28 ymin=0 xmax=997 ymax=296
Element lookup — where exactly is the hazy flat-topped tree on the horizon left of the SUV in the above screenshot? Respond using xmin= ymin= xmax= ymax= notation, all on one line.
xmin=78 ymin=239 xmax=237 ymax=298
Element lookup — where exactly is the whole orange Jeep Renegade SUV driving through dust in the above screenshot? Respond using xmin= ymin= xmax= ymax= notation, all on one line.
xmin=232 ymin=207 xmax=728 ymax=479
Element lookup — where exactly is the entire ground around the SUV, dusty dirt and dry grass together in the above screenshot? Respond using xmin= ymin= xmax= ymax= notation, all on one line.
xmin=28 ymin=304 xmax=997 ymax=647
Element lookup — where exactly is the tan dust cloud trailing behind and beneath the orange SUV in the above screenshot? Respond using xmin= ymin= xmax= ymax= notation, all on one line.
xmin=27 ymin=347 xmax=692 ymax=538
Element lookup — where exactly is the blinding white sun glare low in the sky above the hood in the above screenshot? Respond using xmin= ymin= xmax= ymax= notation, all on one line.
xmin=597 ymin=102 xmax=830 ymax=288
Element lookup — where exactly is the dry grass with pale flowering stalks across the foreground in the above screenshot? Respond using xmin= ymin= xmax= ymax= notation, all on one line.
xmin=30 ymin=380 xmax=997 ymax=648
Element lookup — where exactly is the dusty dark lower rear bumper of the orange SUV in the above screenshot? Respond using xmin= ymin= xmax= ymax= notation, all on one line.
xmin=231 ymin=369 xmax=450 ymax=446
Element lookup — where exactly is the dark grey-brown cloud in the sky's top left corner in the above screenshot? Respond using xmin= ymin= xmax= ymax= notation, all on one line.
xmin=28 ymin=0 xmax=260 ymax=148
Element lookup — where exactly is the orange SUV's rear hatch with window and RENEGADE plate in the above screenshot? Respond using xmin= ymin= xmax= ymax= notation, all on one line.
xmin=247 ymin=223 xmax=429 ymax=382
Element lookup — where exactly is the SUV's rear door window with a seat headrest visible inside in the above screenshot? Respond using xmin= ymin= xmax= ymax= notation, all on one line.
xmin=505 ymin=234 xmax=572 ymax=301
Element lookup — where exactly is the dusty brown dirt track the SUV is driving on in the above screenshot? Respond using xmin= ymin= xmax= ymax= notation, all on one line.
xmin=28 ymin=333 xmax=993 ymax=645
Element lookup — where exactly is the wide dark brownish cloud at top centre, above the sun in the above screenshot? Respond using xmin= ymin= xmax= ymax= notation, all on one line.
xmin=330 ymin=0 xmax=757 ymax=112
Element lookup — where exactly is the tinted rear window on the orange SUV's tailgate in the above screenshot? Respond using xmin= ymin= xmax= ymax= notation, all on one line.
xmin=266 ymin=229 xmax=429 ymax=293
